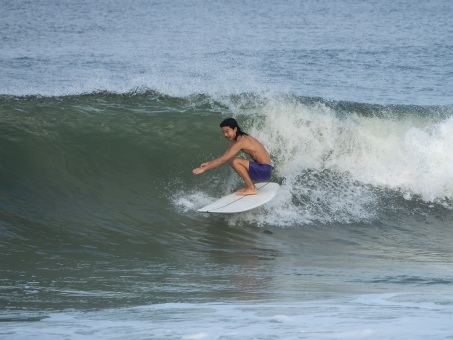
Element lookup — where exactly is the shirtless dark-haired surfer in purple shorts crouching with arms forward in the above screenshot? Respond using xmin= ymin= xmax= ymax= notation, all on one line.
xmin=192 ymin=118 xmax=273 ymax=196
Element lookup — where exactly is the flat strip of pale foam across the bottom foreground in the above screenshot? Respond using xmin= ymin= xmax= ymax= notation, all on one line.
xmin=0 ymin=293 xmax=453 ymax=340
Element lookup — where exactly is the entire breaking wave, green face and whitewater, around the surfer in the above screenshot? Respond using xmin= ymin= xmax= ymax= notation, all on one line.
xmin=0 ymin=91 xmax=453 ymax=232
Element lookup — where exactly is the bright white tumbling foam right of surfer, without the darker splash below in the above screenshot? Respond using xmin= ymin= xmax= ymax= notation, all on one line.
xmin=238 ymin=97 xmax=453 ymax=202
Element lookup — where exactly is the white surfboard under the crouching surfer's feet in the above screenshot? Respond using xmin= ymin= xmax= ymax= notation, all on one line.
xmin=198 ymin=182 xmax=280 ymax=214
